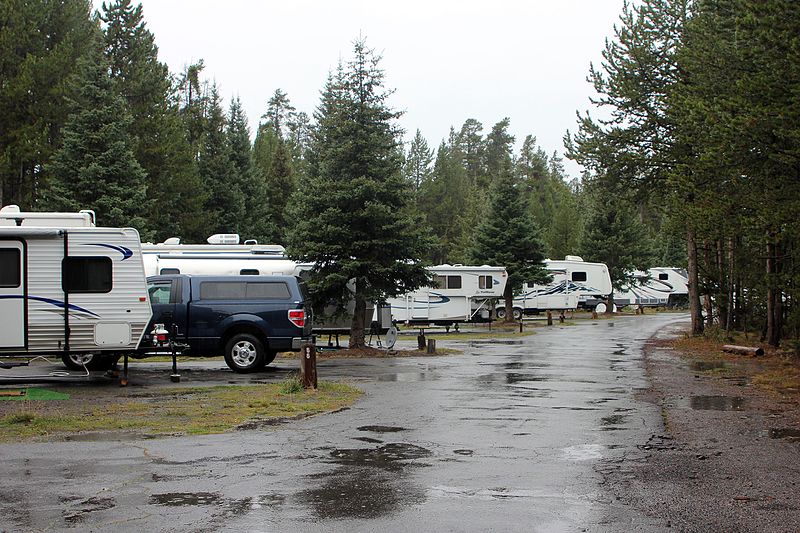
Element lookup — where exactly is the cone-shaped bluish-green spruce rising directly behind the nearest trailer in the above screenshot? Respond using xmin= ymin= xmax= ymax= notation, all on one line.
xmin=45 ymin=53 xmax=147 ymax=231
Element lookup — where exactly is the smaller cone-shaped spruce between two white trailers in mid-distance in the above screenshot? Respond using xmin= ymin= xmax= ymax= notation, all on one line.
xmin=471 ymin=170 xmax=550 ymax=322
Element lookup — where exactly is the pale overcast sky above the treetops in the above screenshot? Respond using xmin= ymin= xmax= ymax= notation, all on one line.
xmin=101 ymin=0 xmax=623 ymax=181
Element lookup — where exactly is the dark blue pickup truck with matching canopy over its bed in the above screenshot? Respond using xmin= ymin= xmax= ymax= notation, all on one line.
xmin=142 ymin=274 xmax=312 ymax=373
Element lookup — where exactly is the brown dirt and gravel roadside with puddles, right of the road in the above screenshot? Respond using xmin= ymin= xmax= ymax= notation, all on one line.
xmin=601 ymin=324 xmax=800 ymax=532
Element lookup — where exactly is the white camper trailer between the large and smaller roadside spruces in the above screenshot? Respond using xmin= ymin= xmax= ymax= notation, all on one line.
xmin=387 ymin=265 xmax=508 ymax=325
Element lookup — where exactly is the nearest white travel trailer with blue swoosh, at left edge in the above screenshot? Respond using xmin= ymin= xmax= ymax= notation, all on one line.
xmin=0 ymin=206 xmax=151 ymax=368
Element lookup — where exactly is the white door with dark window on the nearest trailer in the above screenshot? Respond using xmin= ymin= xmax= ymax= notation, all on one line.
xmin=0 ymin=241 xmax=27 ymax=348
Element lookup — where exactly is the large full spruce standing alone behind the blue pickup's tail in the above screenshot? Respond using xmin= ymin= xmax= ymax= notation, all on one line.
xmin=288 ymin=40 xmax=429 ymax=348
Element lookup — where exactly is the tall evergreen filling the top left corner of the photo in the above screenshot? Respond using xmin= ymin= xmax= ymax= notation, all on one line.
xmin=0 ymin=0 xmax=95 ymax=209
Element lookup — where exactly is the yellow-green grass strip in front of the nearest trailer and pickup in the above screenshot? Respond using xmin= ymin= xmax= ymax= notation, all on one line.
xmin=0 ymin=381 xmax=362 ymax=442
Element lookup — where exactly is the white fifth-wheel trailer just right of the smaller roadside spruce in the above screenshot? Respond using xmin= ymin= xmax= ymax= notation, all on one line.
xmin=496 ymin=255 xmax=612 ymax=319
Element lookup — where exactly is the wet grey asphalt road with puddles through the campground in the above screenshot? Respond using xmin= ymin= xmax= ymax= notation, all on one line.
xmin=0 ymin=314 xmax=686 ymax=532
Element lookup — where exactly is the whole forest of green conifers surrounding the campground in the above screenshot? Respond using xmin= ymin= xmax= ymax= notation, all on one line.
xmin=0 ymin=0 xmax=800 ymax=345
